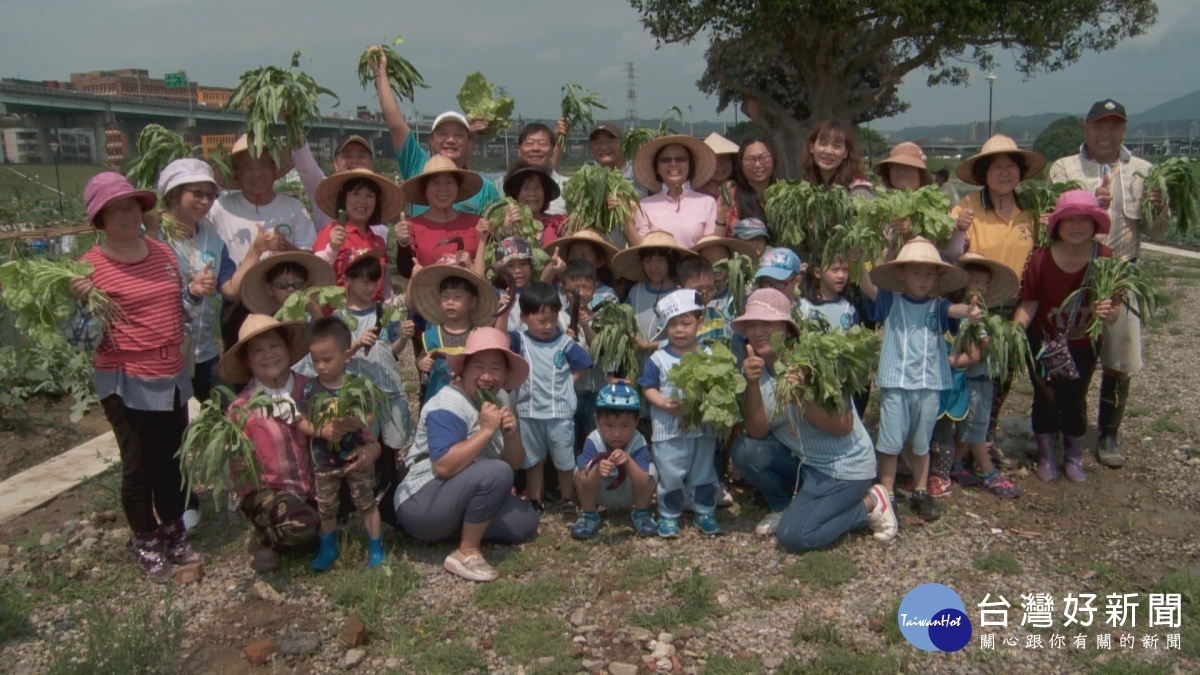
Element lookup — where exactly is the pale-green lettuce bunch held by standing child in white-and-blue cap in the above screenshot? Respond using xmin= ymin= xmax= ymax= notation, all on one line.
xmin=667 ymin=342 xmax=746 ymax=438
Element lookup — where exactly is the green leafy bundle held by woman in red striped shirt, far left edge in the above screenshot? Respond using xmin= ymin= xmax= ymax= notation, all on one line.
xmin=0 ymin=258 xmax=122 ymax=334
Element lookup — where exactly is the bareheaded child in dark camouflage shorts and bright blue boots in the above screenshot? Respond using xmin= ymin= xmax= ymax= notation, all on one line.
xmin=296 ymin=317 xmax=386 ymax=572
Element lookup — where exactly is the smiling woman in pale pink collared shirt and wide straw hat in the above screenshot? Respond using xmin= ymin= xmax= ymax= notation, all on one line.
xmin=625 ymin=136 xmax=725 ymax=249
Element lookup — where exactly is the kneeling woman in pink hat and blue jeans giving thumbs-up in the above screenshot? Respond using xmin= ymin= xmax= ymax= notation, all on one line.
xmin=733 ymin=288 xmax=896 ymax=552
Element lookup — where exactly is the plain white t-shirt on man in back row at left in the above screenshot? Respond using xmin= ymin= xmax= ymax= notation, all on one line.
xmin=209 ymin=191 xmax=317 ymax=264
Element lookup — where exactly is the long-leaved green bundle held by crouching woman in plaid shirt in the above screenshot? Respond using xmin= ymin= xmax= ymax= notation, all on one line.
xmin=175 ymin=386 xmax=274 ymax=506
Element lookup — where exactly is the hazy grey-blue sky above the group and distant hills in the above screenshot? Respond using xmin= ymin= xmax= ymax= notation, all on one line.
xmin=0 ymin=0 xmax=1200 ymax=131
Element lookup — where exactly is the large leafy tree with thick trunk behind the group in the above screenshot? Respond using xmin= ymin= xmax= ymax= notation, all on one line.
xmin=630 ymin=0 xmax=1158 ymax=177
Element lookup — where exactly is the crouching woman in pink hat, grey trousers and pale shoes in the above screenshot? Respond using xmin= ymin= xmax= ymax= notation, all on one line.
xmin=395 ymin=328 xmax=538 ymax=581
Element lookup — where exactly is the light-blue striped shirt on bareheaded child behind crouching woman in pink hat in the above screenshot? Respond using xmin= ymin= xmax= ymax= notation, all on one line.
xmin=509 ymin=330 xmax=592 ymax=419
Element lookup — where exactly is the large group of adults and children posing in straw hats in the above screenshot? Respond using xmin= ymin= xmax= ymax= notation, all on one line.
xmin=66 ymin=64 xmax=1151 ymax=581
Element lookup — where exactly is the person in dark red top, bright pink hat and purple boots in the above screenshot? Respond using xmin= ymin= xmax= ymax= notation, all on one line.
xmin=1013 ymin=190 xmax=1120 ymax=483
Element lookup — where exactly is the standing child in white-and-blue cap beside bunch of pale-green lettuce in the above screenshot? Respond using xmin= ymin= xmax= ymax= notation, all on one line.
xmin=637 ymin=291 xmax=724 ymax=538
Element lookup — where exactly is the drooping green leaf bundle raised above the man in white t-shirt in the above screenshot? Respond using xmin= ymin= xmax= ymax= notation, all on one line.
xmin=222 ymin=52 xmax=341 ymax=160
